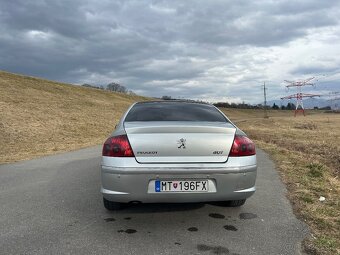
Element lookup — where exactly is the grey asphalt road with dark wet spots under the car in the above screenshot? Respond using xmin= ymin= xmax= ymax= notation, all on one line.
xmin=0 ymin=147 xmax=308 ymax=255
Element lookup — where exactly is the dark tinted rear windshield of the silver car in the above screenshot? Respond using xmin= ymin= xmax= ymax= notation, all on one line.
xmin=125 ymin=102 xmax=227 ymax=122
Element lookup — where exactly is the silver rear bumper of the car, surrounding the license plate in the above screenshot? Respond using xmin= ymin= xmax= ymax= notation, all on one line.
xmin=101 ymin=165 xmax=257 ymax=203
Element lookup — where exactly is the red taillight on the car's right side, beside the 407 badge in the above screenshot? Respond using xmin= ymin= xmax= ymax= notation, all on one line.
xmin=229 ymin=135 xmax=256 ymax=157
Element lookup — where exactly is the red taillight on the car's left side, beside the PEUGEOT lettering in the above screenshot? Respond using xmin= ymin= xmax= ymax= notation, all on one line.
xmin=102 ymin=135 xmax=134 ymax=157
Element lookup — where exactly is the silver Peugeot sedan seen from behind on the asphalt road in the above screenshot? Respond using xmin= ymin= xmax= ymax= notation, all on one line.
xmin=101 ymin=101 xmax=257 ymax=210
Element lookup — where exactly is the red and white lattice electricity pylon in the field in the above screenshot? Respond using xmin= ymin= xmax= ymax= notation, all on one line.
xmin=281 ymin=77 xmax=320 ymax=116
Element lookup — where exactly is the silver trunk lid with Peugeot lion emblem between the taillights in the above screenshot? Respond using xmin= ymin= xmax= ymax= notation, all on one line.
xmin=124 ymin=121 xmax=236 ymax=163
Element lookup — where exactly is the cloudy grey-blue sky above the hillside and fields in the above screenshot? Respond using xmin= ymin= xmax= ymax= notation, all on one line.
xmin=0 ymin=0 xmax=340 ymax=104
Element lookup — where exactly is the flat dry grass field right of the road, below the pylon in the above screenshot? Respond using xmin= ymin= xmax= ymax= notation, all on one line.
xmin=223 ymin=109 xmax=340 ymax=255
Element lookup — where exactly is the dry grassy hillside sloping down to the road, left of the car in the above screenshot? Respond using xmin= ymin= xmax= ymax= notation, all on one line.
xmin=0 ymin=71 xmax=147 ymax=163
